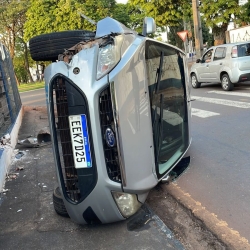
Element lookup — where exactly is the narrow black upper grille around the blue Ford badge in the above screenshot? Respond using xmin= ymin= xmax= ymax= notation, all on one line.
xmin=99 ymin=87 xmax=121 ymax=183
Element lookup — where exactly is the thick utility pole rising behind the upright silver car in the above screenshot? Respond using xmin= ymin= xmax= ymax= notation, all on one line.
xmin=192 ymin=0 xmax=203 ymax=58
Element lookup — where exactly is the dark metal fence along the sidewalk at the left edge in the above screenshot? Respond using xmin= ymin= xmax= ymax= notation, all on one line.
xmin=0 ymin=44 xmax=22 ymax=138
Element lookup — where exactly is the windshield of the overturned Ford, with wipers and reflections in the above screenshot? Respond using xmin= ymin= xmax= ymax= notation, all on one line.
xmin=146 ymin=41 xmax=188 ymax=178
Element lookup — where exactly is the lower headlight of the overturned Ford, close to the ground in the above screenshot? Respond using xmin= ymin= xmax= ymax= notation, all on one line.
xmin=112 ymin=191 xmax=142 ymax=218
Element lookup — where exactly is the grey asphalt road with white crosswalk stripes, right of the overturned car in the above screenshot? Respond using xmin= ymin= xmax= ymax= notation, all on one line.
xmin=177 ymin=83 xmax=250 ymax=242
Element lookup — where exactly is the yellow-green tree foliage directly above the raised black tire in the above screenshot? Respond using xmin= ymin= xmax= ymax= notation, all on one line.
xmin=24 ymin=0 xmax=115 ymax=41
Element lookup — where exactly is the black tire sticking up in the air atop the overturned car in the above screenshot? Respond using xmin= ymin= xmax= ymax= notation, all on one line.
xmin=29 ymin=30 xmax=95 ymax=61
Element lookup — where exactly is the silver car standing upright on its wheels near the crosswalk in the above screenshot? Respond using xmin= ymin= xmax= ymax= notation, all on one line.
xmin=190 ymin=41 xmax=250 ymax=91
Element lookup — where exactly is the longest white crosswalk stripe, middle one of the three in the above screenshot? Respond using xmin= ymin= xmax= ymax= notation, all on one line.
xmin=192 ymin=96 xmax=250 ymax=109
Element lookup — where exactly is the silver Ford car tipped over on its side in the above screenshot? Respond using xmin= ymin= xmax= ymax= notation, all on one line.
xmin=30 ymin=17 xmax=191 ymax=224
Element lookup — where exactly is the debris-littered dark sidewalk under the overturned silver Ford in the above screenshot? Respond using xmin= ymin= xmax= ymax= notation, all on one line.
xmin=0 ymin=107 xmax=184 ymax=250
